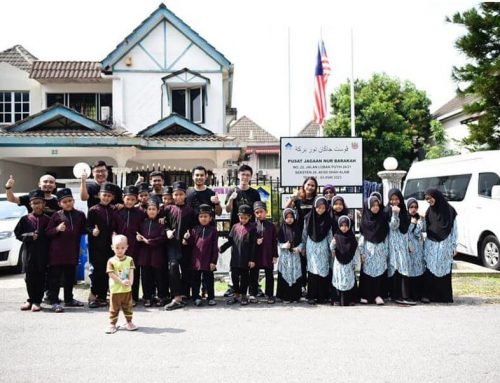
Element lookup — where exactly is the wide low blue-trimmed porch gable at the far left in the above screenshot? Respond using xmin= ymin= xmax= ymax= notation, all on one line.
xmin=4 ymin=104 xmax=114 ymax=133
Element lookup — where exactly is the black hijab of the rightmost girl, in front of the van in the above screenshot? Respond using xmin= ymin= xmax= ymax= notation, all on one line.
xmin=425 ymin=189 xmax=457 ymax=242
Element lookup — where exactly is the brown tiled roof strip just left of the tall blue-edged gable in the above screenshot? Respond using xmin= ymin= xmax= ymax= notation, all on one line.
xmin=30 ymin=61 xmax=101 ymax=80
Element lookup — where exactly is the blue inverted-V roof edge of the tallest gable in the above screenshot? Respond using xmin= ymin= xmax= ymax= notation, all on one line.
xmin=102 ymin=3 xmax=231 ymax=70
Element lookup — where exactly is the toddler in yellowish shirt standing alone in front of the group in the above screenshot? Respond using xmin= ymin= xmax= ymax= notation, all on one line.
xmin=106 ymin=234 xmax=137 ymax=334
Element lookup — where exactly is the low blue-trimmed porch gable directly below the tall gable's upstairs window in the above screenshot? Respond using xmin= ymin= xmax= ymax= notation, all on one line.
xmin=137 ymin=113 xmax=213 ymax=137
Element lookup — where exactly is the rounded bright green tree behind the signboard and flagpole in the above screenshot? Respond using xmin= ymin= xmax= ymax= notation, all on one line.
xmin=325 ymin=74 xmax=431 ymax=180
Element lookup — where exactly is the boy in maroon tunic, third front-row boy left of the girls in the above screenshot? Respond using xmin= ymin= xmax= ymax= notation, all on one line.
xmin=182 ymin=204 xmax=219 ymax=306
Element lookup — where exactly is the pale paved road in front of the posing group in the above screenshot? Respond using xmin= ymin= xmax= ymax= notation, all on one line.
xmin=0 ymin=275 xmax=500 ymax=383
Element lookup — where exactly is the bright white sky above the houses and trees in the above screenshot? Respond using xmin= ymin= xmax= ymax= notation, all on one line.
xmin=0 ymin=0 xmax=478 ymax=137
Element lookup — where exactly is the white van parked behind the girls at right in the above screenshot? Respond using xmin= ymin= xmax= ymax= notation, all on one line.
xmin=403 ymin=150 xmax=500 ymax=270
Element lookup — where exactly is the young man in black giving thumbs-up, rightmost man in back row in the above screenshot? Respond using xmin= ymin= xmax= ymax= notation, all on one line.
xmin=226 ymin=165 xmax=260 ymax=227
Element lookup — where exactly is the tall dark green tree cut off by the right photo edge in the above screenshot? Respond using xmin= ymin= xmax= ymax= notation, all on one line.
xmin=447 ymin=2 xmax=500 ymax=149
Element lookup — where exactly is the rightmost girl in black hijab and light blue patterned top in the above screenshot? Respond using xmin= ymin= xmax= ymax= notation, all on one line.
xmin=424 ymin=189 xmax=458 ymax=303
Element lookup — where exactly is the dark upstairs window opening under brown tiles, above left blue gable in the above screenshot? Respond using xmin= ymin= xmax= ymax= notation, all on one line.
xmin=47 ymin=93 xmax=112 ymax=124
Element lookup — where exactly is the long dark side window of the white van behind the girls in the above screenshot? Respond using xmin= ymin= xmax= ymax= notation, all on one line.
xmin=404 ymin=174 xmax=470 ymax=201
